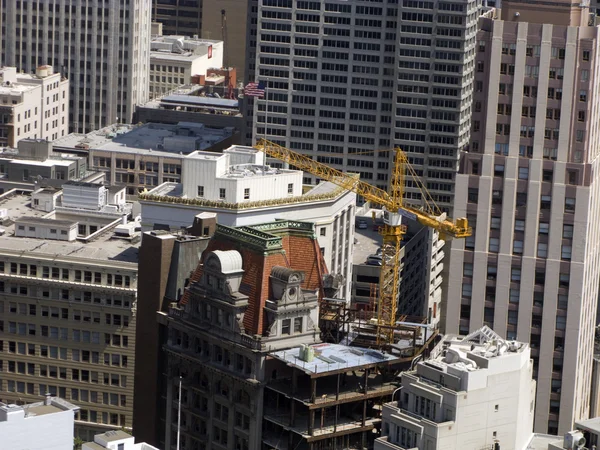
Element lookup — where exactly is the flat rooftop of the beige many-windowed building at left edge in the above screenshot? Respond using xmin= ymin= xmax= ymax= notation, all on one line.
xmin=0 ymin=194 xmax=139 ymax=264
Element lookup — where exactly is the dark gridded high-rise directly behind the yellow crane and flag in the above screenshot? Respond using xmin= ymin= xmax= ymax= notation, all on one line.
xmin=248 ymin=0 xmax=481 ymax=210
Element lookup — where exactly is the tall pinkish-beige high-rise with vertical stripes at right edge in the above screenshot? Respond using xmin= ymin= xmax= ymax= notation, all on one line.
xmin=445 ymin=1 xmax=600 ymax=434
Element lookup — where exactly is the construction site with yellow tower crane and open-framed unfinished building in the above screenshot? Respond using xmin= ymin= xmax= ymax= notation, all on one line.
xmin=251 ymin=141 xmax=471 ymax=450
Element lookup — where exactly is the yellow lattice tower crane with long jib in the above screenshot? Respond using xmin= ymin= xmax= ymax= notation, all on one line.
xmin=255 ymin=139 xmax=472 ymax=346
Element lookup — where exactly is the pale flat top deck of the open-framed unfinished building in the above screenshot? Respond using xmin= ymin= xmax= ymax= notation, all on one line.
xmin=270 ymin=344 xmax=399 ymax=374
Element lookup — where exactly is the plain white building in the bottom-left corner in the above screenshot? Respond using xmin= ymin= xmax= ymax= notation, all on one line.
xmin=0 ymin=395 xmax=79 ymax=450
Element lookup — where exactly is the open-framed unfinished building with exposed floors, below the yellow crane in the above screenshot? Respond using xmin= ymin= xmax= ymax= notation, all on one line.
xmin=263 ymin=343 xmax=422 ymax=450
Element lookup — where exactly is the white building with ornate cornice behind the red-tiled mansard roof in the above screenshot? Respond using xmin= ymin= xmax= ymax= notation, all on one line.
xmin=139 ymin=146 xmax=356 ymax=296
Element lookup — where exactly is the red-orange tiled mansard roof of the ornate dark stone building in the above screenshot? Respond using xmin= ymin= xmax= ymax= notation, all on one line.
xmin=180 ymin=223 xmax=327 ymax=335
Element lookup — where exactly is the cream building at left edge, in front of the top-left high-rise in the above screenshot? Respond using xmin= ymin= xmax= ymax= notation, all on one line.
xmin=0 ymin=66 xmax=69 ymax=147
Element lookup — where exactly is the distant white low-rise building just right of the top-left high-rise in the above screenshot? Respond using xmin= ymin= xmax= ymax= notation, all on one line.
xmin=150 ymin=36 xmax=223 ymax=98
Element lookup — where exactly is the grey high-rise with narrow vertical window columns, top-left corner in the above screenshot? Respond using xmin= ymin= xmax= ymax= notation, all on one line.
xmin=0 ymin=0 xmax=151 ymax=132
